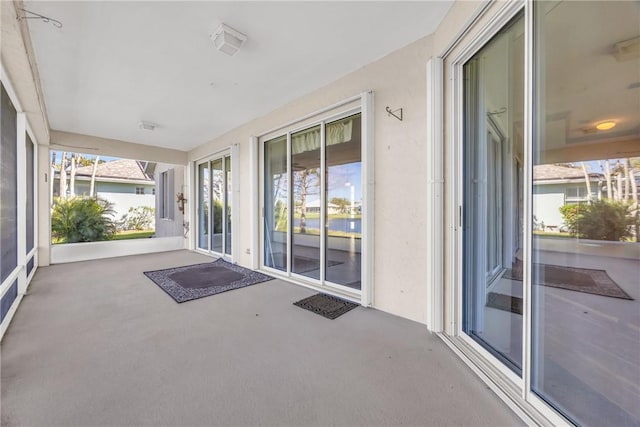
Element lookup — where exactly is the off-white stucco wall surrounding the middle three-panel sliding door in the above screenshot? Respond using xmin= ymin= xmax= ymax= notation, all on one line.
xmin=189 ymin=33 xmax=442 ymax=323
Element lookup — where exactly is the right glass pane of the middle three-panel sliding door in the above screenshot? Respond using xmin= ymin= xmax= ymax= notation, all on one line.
xmin=325 ymin=114 xmax=362 ymax=290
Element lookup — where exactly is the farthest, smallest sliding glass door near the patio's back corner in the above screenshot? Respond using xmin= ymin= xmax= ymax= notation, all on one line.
xmin=197 ymin=156 xmax=232 ymax=256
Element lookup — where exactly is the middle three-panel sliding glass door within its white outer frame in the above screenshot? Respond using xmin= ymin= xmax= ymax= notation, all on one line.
xmin=262 ymin=113 xmax=362 ymax=291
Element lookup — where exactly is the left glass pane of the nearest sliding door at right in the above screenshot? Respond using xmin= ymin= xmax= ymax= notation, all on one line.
xmin=463 ymin=15 xmax=524 ymax=373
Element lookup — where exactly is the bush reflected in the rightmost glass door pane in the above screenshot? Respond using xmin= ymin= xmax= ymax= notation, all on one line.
xmin=560 ymin=200 xmax=634 ymax=241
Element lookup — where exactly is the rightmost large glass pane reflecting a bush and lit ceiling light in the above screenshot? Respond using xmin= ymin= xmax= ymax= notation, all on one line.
xmin=531 ymin=1 xmax=640 ymax=426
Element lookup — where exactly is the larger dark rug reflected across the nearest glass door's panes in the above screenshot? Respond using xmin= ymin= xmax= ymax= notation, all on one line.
xmin=502 ymin=260 xmax=633 ymax=300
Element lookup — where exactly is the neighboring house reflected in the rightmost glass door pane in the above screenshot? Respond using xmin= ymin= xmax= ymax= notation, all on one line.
xmin=533 ymin=165 xmax=604 ymax=231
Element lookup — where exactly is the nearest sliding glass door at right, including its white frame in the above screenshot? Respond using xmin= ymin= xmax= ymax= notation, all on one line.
xmin=450 ymin=1 xmax=640 ymax=426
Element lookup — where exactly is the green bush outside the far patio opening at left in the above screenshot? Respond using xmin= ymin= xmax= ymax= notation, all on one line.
xmin=51 ymin=197 xmax=116 ymax=243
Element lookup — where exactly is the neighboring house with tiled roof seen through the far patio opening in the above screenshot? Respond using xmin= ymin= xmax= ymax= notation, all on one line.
xmin=53 ymin=159 xmax=155 ymax=219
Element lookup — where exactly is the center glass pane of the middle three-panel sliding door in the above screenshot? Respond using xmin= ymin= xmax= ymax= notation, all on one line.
xmin=291 ymin=126 xmax=322 ymax=279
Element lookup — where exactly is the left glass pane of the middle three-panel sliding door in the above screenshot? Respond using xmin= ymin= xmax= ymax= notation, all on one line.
xmin=263 ymin=136 xmax=289 ymax=271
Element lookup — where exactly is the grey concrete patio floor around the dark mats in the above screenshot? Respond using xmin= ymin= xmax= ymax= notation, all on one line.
xmin=1 ymin=251 xmax=522 ymax=426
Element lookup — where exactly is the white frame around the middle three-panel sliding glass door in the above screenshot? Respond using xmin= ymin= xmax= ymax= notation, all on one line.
xmin=250 ymin=91 xmax=374 ymax=307
